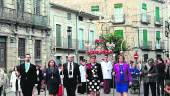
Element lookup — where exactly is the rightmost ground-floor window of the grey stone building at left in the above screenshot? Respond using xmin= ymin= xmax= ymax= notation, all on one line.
xmin=34 ymin=40 xmax=41 ymax=59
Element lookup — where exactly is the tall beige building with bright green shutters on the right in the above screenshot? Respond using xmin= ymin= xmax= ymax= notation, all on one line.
xmin=53 ymin=0 xmax=167 ymax=61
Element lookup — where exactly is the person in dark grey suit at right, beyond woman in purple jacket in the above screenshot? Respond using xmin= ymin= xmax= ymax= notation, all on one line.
xmin=142 ymin=58 xmax=157 ymax=96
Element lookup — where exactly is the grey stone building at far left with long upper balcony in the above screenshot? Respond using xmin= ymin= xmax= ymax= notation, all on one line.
xmin=0 ymin=0 xmax=50 ymax=70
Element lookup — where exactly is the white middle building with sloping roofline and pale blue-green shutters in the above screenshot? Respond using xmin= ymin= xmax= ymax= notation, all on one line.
xmin=50 ymin=2 xmax=99 ymax=64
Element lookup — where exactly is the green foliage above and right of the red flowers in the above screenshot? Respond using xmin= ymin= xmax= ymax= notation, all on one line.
xmin=100 ymin=33 xmax=128 ymax=53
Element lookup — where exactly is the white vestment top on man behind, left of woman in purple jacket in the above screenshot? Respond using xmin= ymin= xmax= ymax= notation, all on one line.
xmin=101 ymin=61 xmax=113 ymax=79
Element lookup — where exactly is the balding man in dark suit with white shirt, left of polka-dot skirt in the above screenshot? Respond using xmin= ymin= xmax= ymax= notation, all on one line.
xmin=63 ymin=55 xmax=80 ymax=96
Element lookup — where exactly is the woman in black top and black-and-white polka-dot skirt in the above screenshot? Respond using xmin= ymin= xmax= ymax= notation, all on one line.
xmin=86 ymin=55 xmax=103 ymax=96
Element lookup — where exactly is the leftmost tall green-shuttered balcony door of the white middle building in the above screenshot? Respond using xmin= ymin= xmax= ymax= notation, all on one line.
xmin=56 ymin=24 xmax=62 ymax=47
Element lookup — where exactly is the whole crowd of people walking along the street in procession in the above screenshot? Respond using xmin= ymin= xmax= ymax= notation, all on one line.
xmin=0 ymin=54 xmax=170 ymax=96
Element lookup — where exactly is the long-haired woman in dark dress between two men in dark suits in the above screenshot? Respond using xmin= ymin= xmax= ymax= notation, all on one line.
xmin=46 ymin=60 xmax=61 ymax=96
